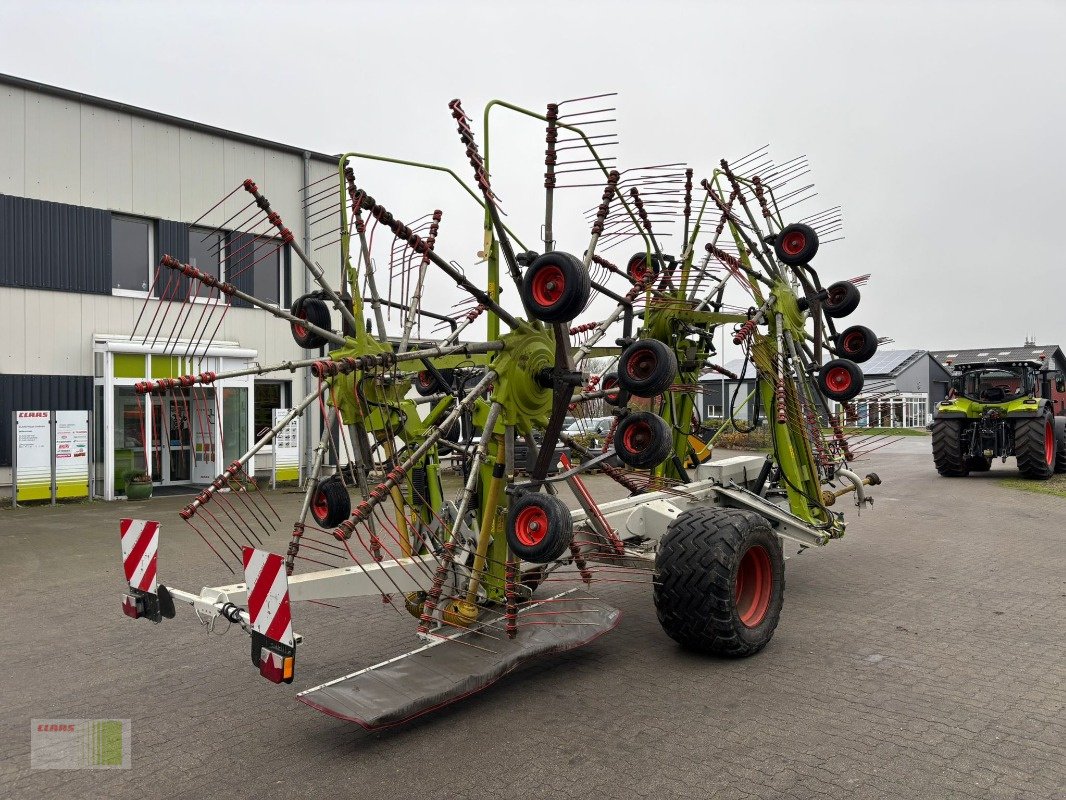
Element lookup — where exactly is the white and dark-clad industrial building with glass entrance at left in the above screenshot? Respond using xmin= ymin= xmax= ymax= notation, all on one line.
xmin=0 ymin=75 xmax=339 ymax=499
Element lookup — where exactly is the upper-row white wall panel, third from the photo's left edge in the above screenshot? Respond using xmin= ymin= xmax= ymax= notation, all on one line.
xmin=80 ymin=103 xmax=134 ymax=213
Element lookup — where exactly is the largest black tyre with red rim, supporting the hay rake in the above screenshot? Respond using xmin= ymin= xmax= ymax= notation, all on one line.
xmin=653 ymin=507 xmax=785 ymax=658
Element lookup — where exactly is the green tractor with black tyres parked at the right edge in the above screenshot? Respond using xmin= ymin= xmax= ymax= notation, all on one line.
xmin=933 ymin=361 xmax=1066 ymax=480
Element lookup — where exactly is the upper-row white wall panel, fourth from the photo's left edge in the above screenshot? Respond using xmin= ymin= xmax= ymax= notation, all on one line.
xmin=132 ymin=119 xmax=181 ymax=220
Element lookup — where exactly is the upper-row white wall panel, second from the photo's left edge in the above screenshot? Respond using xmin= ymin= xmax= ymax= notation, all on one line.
xmin=25 ymin=93 xmax=81 ymax=204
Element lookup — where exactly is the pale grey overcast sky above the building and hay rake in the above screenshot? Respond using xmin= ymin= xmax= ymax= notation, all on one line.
xmin=0 ymin=0 xmax=1066 ymax=350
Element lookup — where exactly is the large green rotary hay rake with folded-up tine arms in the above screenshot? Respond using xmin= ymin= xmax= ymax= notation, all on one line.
xmin=114 ymin=95 xmax=879 ymax=727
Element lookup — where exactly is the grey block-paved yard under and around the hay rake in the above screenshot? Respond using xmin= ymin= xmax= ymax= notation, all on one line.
xmin=0 ymin=439 xmax=1066 ymax=800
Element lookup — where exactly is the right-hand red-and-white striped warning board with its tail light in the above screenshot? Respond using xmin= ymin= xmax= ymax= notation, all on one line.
xmin=244 ymin=547 xmax=296 ymax=684
